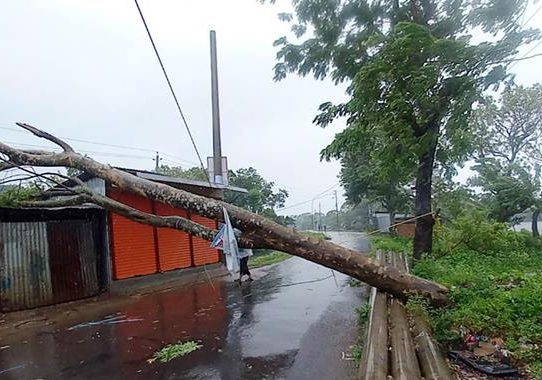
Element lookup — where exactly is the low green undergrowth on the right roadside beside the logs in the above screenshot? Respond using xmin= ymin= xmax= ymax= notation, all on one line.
xmin=373 ymin=220 xmax=542 ymax=376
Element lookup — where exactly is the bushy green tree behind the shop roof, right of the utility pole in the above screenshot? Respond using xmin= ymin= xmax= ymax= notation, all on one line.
xmin=224 ymin=167 xmax=293 ymax=224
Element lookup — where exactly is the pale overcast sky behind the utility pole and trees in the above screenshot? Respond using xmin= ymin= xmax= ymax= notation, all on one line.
xmin=0 ymin=0 xmax=542 ymax=214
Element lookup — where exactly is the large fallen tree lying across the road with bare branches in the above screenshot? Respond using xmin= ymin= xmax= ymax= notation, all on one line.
xmin=0 ymin=123 xmax=448 ymax=305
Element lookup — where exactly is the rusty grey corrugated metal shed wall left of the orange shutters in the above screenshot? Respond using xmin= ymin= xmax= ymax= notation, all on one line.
xmin=0 ymin=211 xmax=105 ymax=311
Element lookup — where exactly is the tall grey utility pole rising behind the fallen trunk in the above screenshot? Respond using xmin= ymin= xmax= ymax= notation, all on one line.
xmin=210 ymin=30 xmax=223 ymax=184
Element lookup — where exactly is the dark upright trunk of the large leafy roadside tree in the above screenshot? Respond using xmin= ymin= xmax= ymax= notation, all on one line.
xmin=414 ymin=127 xmax=437 ymax=260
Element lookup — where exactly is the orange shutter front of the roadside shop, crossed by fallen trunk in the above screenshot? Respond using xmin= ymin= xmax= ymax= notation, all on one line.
xmin=108 ymin=188 xmax=220 ymax=280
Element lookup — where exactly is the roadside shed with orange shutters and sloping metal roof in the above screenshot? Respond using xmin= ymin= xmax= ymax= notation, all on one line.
xmin=67 ymin=168 xmax=247 ymax=280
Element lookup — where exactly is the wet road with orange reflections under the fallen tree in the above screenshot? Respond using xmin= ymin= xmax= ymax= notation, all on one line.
xmin=0 ymin=233 xmax=368 ymax=380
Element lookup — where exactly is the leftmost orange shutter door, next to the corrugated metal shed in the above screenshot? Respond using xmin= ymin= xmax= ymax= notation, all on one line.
xmin=109 ymin=189 xmax=158 ymax=280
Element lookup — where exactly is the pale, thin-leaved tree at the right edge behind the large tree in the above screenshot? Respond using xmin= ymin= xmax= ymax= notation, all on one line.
xmin=472 ymin=84 xmax=542 ymax=236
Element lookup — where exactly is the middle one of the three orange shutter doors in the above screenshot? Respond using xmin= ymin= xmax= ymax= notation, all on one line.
xmin=154 ymin=202 xmax=192 ymax=271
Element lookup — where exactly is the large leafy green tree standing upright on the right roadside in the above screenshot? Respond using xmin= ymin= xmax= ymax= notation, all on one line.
xmin=266 ymin=0 xmax=537 ymax=258
